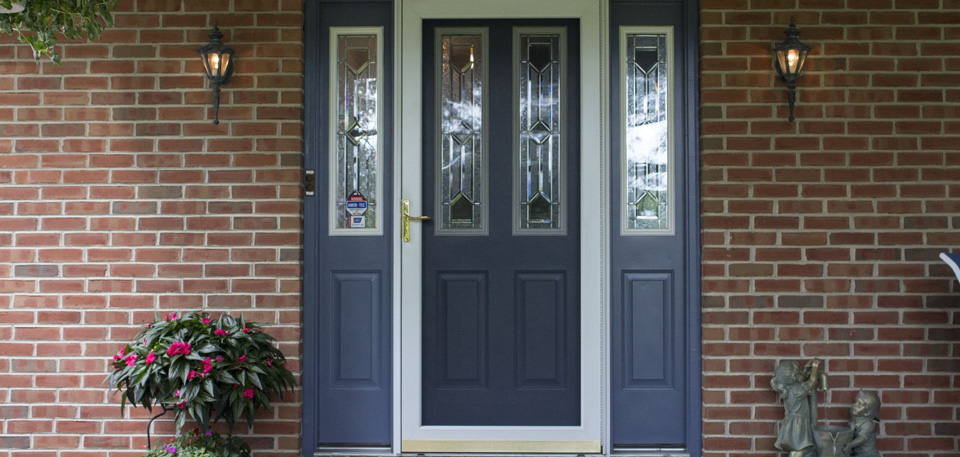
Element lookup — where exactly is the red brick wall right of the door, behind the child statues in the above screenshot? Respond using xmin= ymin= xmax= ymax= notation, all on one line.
xmin=700 ymin=0 xmax=960 ymax=457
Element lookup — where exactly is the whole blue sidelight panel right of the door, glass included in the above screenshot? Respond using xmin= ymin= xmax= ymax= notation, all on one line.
xmin=609 ymin=2 xmax=699 ymax=452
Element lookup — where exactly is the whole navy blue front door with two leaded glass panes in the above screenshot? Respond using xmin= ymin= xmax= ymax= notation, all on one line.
xmin=422 ymin=20 xmax=581 ymax=426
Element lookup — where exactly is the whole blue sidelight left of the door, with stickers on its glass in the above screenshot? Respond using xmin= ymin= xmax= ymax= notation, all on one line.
xmin=312 ymin=2 xmax=395 ymax=448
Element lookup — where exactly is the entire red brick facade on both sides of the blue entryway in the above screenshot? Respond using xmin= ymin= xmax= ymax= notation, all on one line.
xmin=0 ymin=0 xmax=960 ymax=457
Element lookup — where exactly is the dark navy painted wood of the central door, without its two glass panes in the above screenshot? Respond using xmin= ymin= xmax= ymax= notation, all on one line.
xmin=422 ymin=20 xmax=580 ymax=425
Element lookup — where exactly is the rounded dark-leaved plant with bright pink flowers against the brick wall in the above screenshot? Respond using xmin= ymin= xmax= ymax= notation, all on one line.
xmin=108 ymin=313 xmax=296 ymax=432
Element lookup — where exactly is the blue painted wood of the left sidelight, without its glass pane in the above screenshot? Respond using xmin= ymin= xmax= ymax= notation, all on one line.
xmin=303 ymin=0 xmax=395 ymax=448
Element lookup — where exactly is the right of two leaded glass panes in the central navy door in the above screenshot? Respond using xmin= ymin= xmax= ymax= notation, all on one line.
xmin=518 ymin=33 xmax=562 ymax=230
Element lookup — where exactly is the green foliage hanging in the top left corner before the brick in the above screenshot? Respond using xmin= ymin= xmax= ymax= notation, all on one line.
xmin=0 ymin=0 xmax=119 ymax=64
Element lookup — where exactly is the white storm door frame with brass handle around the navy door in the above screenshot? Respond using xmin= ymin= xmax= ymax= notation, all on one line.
xmin=393 ymin=0 xmax=609 ymax=453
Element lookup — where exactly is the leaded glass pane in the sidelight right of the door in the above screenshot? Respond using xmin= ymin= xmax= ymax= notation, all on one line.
xmin=622 ymin=34 xmax=671 ymax=231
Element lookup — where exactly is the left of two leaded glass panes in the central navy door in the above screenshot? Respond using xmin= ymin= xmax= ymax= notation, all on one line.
xmin=438 ymin=34 xmax=486 ymax=230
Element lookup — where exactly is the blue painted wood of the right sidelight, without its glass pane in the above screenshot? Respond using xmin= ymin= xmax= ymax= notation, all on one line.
xmin=609 ymin=0 xmax=701 ymax=448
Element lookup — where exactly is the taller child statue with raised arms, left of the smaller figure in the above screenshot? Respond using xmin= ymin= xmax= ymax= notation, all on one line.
xmin=770 ymin=359 xmax=823 ymax=457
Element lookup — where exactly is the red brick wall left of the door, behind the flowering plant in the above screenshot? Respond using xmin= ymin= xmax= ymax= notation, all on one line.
xmin=0 ymin=0 xmax=303 ymax=457
